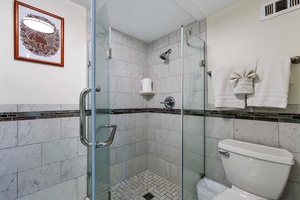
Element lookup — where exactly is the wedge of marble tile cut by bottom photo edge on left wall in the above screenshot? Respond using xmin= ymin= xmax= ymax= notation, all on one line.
xmin=17 ymin=179 xmax=77 ymax=200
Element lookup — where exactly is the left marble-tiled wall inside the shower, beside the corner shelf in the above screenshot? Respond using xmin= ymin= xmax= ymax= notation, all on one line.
xmin=109 ymin=29 xmax=148 ymax=185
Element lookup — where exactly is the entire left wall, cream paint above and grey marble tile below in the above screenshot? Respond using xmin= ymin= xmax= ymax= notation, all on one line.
xmin=0 ymin=0 xmax=86 ymax=200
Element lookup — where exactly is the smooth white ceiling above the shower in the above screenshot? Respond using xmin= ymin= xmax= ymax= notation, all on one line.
xmin=71 ymin=0 xmax=240 ymax=42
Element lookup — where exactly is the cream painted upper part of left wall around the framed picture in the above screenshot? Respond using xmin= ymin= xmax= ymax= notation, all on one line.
xmin=0 ymin=0 xmax=86 ymax=104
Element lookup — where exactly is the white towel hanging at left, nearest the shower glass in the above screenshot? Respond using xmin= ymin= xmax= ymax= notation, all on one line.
xmin=212 ymin=66 xmax=246 ymax=109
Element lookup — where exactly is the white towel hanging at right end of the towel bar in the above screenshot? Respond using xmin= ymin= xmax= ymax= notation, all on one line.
xmin=247 ymin=56 xmax=291 ymax=108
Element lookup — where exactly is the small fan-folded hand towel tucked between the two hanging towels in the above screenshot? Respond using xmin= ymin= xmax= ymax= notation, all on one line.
xmin=229 ymin=68 xmax=255 ymax=94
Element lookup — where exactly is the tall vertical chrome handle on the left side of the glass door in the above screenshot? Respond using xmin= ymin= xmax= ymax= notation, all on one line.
xmin=79 ymin=88 xmax=92 ymax=147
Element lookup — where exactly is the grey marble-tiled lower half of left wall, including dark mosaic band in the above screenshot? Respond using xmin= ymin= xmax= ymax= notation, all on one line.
xmin=0 ymin=104 xmax=87 ymax=200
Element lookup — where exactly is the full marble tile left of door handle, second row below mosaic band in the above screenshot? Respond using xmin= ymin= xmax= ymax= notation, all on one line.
xmin=42 ymin=138 xmax=78 ymax=165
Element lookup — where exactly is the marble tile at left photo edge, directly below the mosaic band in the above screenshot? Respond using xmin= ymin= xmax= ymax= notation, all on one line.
xmin=0 ymin=121 xmax=18 ymax=149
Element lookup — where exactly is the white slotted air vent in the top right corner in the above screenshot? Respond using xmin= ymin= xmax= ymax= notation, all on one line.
xmin=260 ymin=0 xmax=300 ymax=21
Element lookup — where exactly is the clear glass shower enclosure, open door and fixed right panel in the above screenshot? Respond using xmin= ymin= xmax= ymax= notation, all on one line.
xmin=81 ymin=0 xmax=206 ymax=200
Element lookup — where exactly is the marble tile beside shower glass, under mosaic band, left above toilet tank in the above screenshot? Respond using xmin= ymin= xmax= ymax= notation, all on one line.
xmin=205 ymin=117 xmax=234 ymax=139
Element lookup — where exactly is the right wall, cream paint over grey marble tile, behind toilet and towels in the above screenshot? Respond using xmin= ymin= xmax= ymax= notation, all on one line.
xmin=205 ymin=0 xmax=300 ymax=199
